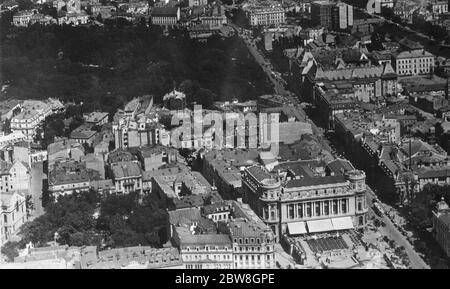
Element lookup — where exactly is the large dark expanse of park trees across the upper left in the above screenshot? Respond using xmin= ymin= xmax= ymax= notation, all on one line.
xmin=0 ymin=22 xmax=272 ymax=113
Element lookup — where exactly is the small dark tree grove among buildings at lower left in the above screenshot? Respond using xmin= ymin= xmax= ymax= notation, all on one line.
xmin=17 ymin=190 xmax=167 ymax=247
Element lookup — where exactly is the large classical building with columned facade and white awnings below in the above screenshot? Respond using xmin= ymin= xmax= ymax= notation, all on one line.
xmin=242 ymin=166 xmax=368 ymax=237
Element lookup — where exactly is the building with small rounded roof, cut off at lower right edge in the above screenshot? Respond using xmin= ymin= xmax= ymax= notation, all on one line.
xmin=432 ymin=198 xmax=450 ymax=257
